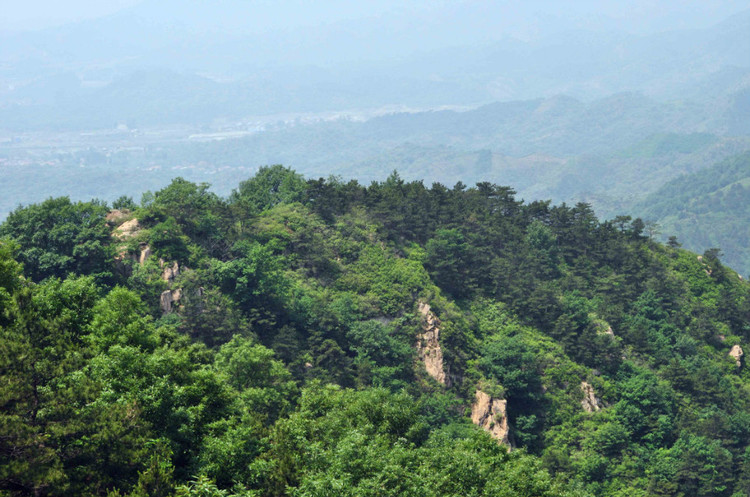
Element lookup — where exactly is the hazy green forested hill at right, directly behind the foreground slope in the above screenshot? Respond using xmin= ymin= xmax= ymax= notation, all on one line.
xmin=634 ymin=153 xmax=750 ymax=276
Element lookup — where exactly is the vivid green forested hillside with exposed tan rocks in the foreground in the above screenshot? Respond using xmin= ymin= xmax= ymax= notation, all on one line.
xmin=0 ymin=166 xmax=750 ymax=497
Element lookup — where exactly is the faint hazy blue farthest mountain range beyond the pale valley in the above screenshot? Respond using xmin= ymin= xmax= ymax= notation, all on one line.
xmin=0 ymin=2 xmax=750 ymax=131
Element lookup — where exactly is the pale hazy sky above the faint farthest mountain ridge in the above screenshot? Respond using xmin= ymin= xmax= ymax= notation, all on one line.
xmin=0 ymin=0 xmax=750 ymax=33
